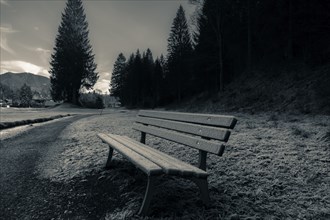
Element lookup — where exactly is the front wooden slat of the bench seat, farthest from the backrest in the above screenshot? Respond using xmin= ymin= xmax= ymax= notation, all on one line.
xmin=98 ymin=133 xmax=163 ymax=176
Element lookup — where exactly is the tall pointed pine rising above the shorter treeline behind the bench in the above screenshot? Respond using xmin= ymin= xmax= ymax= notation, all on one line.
xmin=167 ymin=5 xmax=192 ymax=101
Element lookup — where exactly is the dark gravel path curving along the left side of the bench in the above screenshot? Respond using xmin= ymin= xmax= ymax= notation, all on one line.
xmin=0 ymin=116 xmax=120 ymax=220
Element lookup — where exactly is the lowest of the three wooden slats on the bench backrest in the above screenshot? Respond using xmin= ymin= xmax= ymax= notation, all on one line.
xmin=133 ymin=124 xmax=224 ymax=155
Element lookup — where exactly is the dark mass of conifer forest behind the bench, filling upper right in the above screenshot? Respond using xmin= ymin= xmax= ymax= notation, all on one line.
xmin=110 ymin=0 xmax=330 ymax=112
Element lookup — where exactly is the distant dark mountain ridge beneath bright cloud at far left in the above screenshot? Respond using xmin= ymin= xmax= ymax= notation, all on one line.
xmin=0 ymin=72 xmax=50 ymax=97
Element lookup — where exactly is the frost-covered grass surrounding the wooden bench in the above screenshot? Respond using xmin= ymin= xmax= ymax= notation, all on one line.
xmin=40 ymin=111 xmax=330 ymax=219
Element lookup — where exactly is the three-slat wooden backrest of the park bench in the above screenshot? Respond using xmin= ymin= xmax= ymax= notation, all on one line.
xmin=133 ymin=110 xmax=237 ymax=156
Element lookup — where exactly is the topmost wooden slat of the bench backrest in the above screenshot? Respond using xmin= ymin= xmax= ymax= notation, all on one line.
xmin=138 ymin=110 xmax=237 ymax=129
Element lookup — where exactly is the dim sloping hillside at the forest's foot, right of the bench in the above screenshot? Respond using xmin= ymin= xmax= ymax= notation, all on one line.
xmin=177 ymin=66 xmax=330 ymax=114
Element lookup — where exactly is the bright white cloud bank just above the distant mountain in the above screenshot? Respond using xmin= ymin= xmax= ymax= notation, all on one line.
xmin=0 ymin=60 xmax=49 ymax=77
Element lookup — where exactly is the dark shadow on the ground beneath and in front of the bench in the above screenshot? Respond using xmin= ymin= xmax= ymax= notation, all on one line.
xmin=29 ymin=160 xmax=218 ymax=219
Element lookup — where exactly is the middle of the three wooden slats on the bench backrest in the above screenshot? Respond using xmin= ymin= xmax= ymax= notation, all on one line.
xmin=136 ymin=117 xmax=230 ymax=142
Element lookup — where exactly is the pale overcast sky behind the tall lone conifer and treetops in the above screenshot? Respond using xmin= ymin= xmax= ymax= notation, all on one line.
xmin=0 ymin=0 xmax=194 ymax=91
